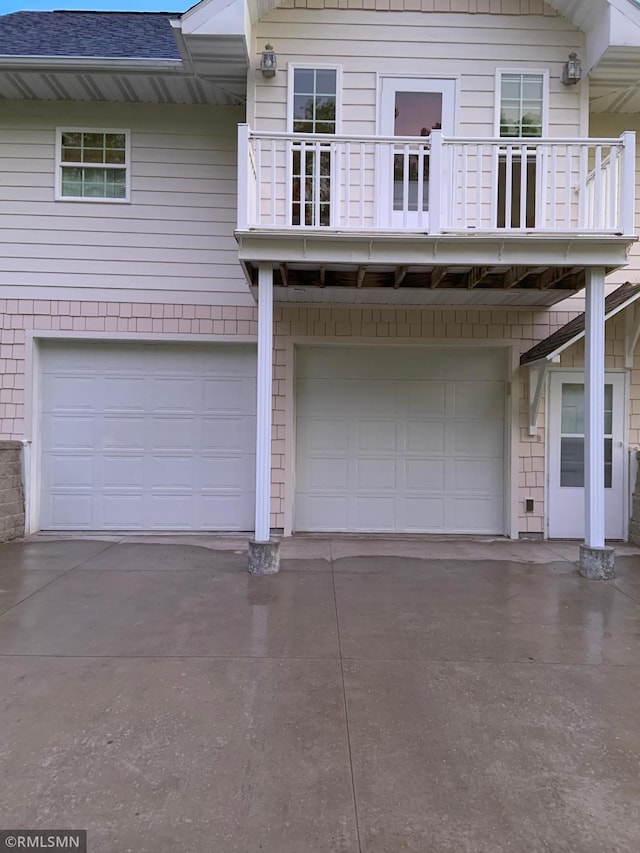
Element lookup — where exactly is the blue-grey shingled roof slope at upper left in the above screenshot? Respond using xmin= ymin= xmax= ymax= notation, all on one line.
xmin=0 ymin=11 xmax=181 ymax=60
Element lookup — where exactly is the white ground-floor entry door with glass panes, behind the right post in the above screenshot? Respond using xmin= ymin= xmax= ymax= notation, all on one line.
xmin=548 ymin=372 xmax=626 ymax=539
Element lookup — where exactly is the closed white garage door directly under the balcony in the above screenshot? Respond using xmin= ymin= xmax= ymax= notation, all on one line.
xmin=295 ymin=346 xmax=506 ymax=533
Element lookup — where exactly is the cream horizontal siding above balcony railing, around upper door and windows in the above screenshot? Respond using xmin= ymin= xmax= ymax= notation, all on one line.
xmin=248 ymin=7 xmax=585 ymax=136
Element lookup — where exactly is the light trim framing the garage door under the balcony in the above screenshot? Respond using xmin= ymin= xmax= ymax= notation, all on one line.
xmin=282 ymin=335 xmax=520 ymax=539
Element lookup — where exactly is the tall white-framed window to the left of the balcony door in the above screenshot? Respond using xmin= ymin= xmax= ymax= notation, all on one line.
xmin=290 ymin=67 xmax=338 ymax=225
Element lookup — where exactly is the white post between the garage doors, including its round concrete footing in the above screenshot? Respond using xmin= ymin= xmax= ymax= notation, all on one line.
xmin=249 ymin=263 xmax=280 ymax=575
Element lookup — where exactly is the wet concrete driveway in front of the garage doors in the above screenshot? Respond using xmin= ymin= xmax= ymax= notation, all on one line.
xmin=0 ymin=537 xmax=640 ymax=853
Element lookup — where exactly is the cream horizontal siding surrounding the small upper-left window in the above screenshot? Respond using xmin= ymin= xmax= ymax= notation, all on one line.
xmin=0 ymin=102 xmax=251 ymax=304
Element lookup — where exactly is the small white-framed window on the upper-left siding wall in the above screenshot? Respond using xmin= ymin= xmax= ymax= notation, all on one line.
xmin=56 ymin=129 xmax=130 ymax=202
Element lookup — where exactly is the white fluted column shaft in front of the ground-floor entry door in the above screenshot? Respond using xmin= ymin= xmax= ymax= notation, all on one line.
xmin=584 ymin=267 xmax=605 ymax=548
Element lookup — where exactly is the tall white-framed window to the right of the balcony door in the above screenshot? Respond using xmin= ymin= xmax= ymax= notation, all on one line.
xmin=497 ymin=71 xmax=547 ymax=228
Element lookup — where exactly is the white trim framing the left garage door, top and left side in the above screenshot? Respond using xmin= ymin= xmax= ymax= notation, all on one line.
xmin=23 ymin=329 xmax=256 ymax=534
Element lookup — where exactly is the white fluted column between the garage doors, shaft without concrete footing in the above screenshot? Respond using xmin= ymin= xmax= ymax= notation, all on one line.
xmin=255 ymin=264 xmax=273 ymax=542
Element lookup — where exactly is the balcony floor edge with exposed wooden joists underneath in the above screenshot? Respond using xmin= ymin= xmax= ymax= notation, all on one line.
xmin=236 ymin=229 xmax=629 ymax=306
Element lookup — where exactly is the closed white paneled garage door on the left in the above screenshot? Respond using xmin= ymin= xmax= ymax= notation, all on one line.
xmin=40 ymin=342 xmax=256 ymax=530
